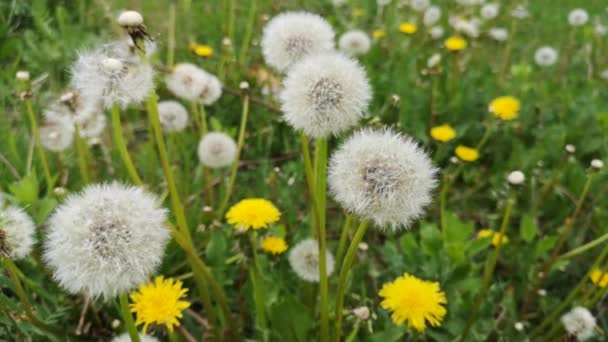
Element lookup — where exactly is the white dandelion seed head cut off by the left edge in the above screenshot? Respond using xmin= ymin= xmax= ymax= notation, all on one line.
xmin=0 ymin=206 xmax=36 ymax=260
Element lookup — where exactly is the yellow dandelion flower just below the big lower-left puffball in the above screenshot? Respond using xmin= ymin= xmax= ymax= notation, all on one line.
xmin=130 ymin=276 xmax=190 ymax=334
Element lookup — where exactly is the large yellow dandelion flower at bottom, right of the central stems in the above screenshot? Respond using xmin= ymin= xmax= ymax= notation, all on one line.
xmin=379 ymin=273 xmax=448 ymax=332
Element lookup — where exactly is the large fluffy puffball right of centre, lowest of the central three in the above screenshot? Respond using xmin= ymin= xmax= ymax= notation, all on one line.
xmin=328 ymin=129 xmax=437 ymax=230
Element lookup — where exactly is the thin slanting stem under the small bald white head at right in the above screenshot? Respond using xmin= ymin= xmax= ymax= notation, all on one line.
xmin=460 ymin=196 xmax=515 ymax=341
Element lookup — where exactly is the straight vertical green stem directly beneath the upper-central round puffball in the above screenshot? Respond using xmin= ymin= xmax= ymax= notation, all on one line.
xmin=315 ymin=138 xmax=329 ymax=342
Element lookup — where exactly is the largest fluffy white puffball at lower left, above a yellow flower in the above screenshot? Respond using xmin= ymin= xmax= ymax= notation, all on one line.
xmin=44 ymin=183 xmax=169 ymax=299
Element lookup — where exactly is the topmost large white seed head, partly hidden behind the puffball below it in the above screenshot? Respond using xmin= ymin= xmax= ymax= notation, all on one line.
xmin=261 ymin=12 xmax=334 ymax=71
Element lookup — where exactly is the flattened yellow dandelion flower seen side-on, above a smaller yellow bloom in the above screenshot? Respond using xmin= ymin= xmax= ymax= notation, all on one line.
xmin=226 ymin=198 xmax=281 ymax=230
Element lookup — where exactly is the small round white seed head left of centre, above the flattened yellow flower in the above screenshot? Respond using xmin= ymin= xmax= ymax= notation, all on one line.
xmin=198 ymin=132 xmax=237 ymax=169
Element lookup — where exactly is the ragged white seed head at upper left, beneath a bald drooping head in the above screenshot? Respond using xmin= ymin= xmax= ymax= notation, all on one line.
xmin=71 ymin=44 xmax=154 ymax=108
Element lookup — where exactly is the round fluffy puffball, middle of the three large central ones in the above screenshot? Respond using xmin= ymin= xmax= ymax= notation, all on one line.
xmin=280 ymin=53 xmax=372 ymax=138
